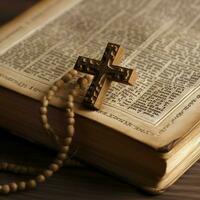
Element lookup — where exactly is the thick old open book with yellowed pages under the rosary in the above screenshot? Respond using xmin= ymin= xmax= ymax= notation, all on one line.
xmin=0 ymin=0 xmax=200 ymax=193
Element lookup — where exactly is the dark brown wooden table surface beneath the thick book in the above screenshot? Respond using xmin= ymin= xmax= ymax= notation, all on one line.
xmin=0 ymin=0 xmax=200 ymax=200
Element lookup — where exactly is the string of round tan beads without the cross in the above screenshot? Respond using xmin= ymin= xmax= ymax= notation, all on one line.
xmin=0 ymin=70 xmax=91 ymax=194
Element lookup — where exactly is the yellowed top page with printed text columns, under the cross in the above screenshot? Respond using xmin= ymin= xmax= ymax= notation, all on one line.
xmin=0 ymin=0 xmax=200 ymax=146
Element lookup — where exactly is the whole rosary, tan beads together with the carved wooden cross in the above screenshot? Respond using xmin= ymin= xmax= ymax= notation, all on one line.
xmin=0 ymin=43 xmax=137 ymax=194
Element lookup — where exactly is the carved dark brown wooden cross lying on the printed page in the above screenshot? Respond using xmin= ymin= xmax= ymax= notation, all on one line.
xmin=74 ymin=43 xmax=137 ymax=110
